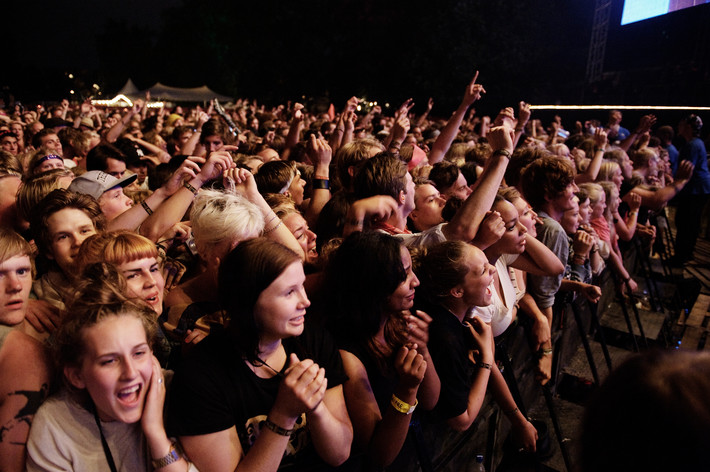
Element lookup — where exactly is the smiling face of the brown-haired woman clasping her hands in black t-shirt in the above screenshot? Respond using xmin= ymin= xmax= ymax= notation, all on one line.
xmin=254 ymin=261 xmax=311 ymax=343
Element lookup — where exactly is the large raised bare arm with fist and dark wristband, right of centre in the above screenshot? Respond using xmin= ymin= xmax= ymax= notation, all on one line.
xmin=442 ymin=126 xmax=513 ymax=242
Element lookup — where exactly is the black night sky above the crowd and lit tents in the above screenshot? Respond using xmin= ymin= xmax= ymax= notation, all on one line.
xmin=5 ymin=0 xmax=710 ymax=124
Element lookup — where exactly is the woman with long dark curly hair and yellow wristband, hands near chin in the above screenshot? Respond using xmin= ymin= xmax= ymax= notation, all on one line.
xmin=325 ymin=232 xmax=440 ymax=470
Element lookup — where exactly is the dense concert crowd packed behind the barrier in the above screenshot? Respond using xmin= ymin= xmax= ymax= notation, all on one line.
xmin=0 ymin=74 xmax=710 ymax=472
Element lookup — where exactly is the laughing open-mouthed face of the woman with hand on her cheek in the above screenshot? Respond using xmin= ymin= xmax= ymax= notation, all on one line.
xmin=64 ymin=314 xmax=153 ymax=424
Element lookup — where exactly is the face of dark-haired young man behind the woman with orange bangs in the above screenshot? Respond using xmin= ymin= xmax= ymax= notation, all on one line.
xmin=47 ymin=208 xmax=96 ymax=274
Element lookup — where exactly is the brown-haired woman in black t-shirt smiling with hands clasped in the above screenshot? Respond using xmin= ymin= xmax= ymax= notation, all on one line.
xmin=170 ymin=238 xmax=352 ymax=471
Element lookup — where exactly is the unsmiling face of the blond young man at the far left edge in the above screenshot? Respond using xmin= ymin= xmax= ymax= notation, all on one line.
xmin=0 ymin=255 xmax=32 ymax=326
